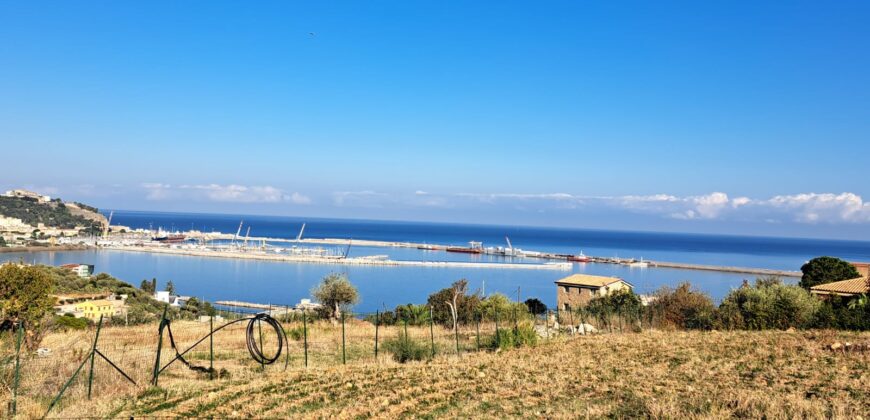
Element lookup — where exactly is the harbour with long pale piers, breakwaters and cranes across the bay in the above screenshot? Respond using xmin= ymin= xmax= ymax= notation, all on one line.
xmin=58 ymin=218 xmax=801 ymax=278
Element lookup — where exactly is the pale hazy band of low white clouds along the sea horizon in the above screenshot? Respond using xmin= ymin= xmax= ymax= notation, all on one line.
xmin=4 ymin=182 xmax=870 ymax=239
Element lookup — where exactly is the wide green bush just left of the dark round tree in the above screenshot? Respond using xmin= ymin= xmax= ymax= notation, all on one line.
xmin=719 ymin=278 xmax=821 ymax=330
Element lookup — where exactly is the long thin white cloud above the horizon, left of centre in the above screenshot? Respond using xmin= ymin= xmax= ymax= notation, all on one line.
xmin=142 ymin=183 xmax=311 ymax=204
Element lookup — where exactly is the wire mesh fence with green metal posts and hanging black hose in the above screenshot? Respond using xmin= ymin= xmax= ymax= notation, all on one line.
xmin=0 ymin=307 xmax=643 ymax=415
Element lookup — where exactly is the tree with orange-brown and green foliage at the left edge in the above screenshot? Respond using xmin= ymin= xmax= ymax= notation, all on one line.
xmin=0 ymin=264 xmax=54 ymax=349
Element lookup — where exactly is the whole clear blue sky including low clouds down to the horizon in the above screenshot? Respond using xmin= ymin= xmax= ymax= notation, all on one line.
xmin=0 ymin=1 xmax=870 ymax=238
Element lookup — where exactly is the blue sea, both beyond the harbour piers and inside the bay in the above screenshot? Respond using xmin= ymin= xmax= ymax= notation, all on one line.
xmin=0 ymin=210 xmax=870 ymax=312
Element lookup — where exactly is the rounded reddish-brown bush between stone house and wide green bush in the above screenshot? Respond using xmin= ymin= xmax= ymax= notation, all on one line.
xmin=648 ymin=283 xmax=716 ymax=330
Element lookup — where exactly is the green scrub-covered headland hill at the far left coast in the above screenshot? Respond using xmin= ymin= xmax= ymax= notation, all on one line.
xmin=0 ymin=197 xmax=102 ymax=234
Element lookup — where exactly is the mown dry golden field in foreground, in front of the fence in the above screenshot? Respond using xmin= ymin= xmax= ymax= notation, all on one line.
xmin=10 ymin=327 xmax=870 ymax=418
